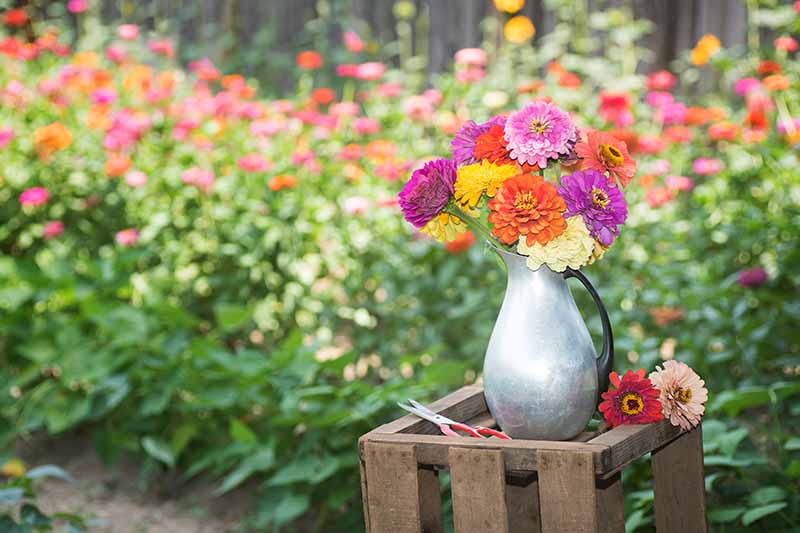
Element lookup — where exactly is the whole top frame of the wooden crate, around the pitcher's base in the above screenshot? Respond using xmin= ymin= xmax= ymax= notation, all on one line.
xmin=359 ymin=385 xmax=681 ymax=478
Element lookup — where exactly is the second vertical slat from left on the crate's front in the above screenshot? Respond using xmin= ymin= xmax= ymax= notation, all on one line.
xmin=449 ymin=448 xmax=508 ymax=533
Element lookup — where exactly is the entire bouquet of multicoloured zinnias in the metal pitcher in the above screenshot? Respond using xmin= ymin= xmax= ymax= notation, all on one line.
xmin=399 ymin=100 xmax=636 ymax=272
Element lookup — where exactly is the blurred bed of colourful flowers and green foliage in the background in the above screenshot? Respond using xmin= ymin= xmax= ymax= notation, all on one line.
xmin=0 ymin=2 xmax=800 ymax=531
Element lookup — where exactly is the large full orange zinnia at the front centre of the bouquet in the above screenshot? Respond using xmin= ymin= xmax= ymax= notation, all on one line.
xmin=488 ymin=174 xmax=567 ymax=246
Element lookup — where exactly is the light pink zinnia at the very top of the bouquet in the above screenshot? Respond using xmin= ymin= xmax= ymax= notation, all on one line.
xmin=505 ymin=101 xmax=578 ymax=168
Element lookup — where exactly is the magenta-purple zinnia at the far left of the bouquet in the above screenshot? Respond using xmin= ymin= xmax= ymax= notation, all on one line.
xmin=398 ymin=159 xmax=456 ymax=228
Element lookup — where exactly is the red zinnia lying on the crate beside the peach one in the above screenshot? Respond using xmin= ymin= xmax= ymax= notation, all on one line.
xmin=600 ymin=368 xmax=664 ymax=427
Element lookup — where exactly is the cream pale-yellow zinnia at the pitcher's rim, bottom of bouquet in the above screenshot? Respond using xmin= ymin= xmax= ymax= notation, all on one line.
xmin=517 ymin=215 xmax=594 ymax=272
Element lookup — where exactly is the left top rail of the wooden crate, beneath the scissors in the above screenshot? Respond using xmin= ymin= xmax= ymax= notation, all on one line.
xmin=370 ymin=385 xmax=488 ymax=435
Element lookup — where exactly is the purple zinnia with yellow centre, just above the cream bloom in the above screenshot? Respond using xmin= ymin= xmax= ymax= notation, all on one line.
xmin=558 ymin=169 xmax=628 ymax=246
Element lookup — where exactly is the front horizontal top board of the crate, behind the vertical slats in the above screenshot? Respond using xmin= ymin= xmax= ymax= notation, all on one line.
xmin=361 ymin=433 xmax=607 ymax=473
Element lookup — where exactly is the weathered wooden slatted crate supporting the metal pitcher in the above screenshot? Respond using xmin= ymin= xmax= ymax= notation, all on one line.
xmin=358 ymin=386 xmax=707 ymax=533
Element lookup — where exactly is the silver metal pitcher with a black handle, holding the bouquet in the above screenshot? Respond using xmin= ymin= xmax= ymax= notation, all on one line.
xmin=483 ymin=245 xmax=614 ymax=440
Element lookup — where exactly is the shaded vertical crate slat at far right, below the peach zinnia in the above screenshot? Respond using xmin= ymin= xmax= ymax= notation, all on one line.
xmin=651 ymin=426 xmax=708 ymax=533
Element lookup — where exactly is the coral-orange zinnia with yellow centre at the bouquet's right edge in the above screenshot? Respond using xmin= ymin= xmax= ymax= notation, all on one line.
xmin=575 ymin=130 xmax=636 ymax=187
